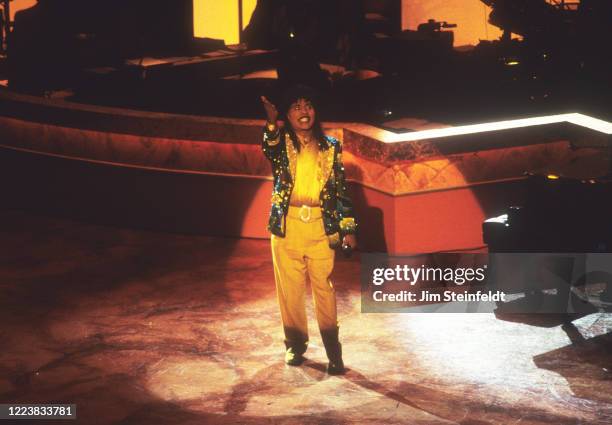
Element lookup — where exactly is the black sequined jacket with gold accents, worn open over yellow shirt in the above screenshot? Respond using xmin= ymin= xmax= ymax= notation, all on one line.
xmin=262 ymin=125 xmax=357 ymax=242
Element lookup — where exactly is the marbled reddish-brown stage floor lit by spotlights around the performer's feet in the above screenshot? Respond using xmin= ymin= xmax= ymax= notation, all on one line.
xmin=0 ymin=211 xmax=612 ymax=425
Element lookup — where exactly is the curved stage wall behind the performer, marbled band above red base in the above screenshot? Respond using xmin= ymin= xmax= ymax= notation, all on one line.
xmin=0 ymin=91 xmax=610 ymax=253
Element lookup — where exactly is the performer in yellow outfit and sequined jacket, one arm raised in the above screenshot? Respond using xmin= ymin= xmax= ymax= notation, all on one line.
xmin=261 ymin=86 xmax=356 ymax=375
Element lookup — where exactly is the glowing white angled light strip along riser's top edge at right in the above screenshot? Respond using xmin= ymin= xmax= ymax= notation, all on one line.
xmin=385 ymin=113 xmax=612 ymax=143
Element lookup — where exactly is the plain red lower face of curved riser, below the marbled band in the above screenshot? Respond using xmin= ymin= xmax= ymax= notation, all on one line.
xmin=0 ymin=149 xmax=522 ymax=253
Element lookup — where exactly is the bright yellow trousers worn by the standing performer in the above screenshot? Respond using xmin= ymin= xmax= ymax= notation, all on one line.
xmin=271 ymin=207 xmax=338 ymax=352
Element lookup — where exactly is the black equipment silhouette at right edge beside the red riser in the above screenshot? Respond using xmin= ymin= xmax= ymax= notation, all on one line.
xmin=482 ymin=174 xmax=612 ymax=313
